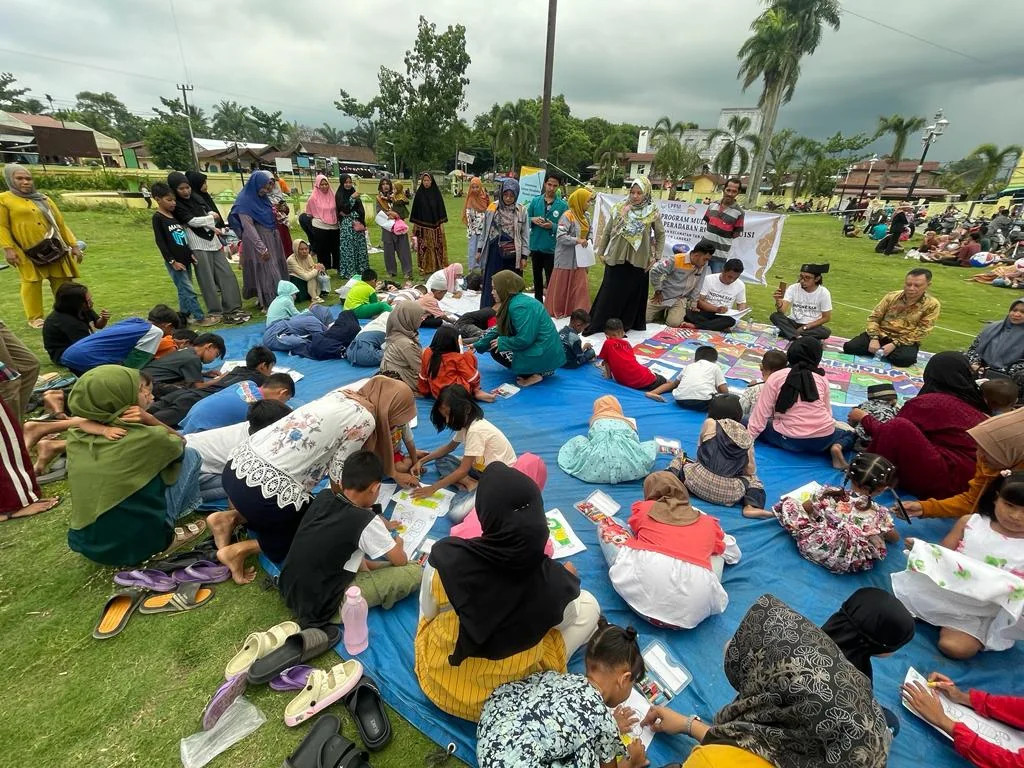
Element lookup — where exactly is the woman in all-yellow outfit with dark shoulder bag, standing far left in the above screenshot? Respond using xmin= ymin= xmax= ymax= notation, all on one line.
xmin=0 ymin=163 xmax=82 ymax=329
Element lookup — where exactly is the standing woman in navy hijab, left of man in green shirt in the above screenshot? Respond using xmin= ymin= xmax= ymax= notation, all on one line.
xmin=476 ymin=178 xmax=529 ymax=309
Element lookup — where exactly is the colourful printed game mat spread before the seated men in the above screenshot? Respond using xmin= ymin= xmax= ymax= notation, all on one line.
xmin=634 ymin=323 xmax=931 ymax=406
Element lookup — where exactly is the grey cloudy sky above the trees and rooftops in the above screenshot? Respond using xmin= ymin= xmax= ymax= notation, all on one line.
xmin=0 ymin=0 xmax=1024 ymax=160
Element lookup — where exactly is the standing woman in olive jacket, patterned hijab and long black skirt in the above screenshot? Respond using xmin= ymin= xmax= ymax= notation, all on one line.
xmin=584 ymin=176 xmax=665 ymax=336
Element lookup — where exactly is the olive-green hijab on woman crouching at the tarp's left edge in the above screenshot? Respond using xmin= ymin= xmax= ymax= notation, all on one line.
xmin=68 ymin=366 xmax=184 ymax=530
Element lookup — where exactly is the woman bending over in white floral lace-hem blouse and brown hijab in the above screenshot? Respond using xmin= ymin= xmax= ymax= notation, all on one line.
xmin=214 ymin=376 xmax=419 ymax=584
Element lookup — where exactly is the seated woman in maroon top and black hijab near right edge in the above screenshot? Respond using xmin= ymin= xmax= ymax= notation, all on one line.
xmin=847 ymin=352 xmax=986 ymax=499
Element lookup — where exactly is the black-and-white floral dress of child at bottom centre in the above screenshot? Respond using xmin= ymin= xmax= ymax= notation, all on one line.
xmin=476 ymin=672 xmax=626 ymax=768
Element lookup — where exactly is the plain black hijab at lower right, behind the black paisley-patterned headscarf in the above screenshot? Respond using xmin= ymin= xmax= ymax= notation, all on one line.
xmin=821 ymin=587 xmax=914 ymax=680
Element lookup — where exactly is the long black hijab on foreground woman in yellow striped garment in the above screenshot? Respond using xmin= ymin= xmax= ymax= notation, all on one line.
xmin=429 ymin=462 xmax=580 ymax=667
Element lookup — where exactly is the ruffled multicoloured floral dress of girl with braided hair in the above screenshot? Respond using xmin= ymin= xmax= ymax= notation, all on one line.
xmin=772 ymin=485 xmax=893 ymax=573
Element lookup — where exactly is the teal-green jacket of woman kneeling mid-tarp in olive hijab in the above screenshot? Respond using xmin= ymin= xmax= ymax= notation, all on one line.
xmin=473 ymin=293 xmax=565 ymax=375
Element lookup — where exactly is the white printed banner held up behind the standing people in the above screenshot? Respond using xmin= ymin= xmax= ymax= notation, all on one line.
xmin=593 ymin=194 xmax=785 ymax=286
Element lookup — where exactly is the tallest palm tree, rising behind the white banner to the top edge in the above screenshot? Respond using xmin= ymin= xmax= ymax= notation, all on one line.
xmin=738 ymin=0 xmax=840 ymax=206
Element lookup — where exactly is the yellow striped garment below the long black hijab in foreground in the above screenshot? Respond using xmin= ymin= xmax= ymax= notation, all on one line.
xmin=415 ymin=572 xmax=567 ymax=723
